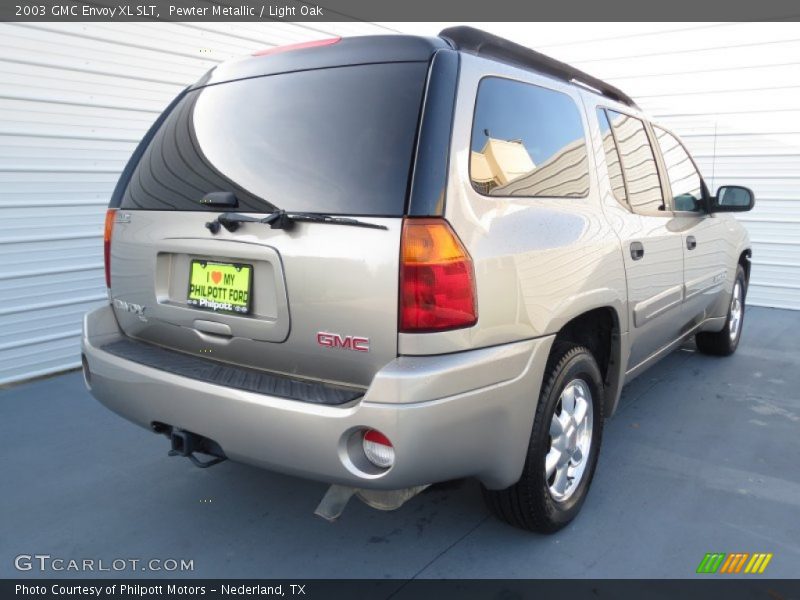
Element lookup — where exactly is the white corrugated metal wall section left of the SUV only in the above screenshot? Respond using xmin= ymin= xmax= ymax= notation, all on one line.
xmin=0 ymin=23 xmax=396 ymax=384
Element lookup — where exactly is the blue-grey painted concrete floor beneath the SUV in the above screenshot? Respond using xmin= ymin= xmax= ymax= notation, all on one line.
xmin=0 ymin=308 xmax=800 ymax=579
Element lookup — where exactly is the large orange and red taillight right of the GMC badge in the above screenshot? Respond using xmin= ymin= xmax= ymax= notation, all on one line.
xmin=400 ymin=219 xmax=478 ymax=333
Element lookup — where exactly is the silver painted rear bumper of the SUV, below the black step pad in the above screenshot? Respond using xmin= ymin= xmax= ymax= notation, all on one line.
xmin=82 ymin=307 xmax=552 ymax=490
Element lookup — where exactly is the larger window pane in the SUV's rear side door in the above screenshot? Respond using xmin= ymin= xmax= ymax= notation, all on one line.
xmin=608 ymin=110 xmax=665 ymax=214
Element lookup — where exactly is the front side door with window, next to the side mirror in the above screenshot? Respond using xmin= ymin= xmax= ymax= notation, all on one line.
xmin=653 ymin=125 xmax=726 ymax=324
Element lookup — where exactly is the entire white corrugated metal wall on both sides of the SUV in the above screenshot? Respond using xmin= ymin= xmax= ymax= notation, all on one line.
xmin=0 ymin=23 xmax=800 ymax=384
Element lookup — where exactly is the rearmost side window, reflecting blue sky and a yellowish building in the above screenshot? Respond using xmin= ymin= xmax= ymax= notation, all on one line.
xmin=470 ymin=77 xmax=589 ymax=198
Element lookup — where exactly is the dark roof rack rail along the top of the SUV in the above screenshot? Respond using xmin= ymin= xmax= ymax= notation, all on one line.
xmin=439 ymin=26 xmax=638 ymax=108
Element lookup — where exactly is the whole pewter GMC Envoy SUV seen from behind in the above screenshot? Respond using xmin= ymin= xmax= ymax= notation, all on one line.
xmin=82 ymin=27 xmax=754 ymax=532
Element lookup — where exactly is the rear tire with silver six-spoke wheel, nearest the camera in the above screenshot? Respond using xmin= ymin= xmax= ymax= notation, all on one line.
xmin=483 ymin=342 xmax=604 ymax=533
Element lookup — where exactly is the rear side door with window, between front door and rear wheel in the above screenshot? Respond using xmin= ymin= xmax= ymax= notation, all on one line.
xmin=597 ymin=108 xmax=683 ymax=370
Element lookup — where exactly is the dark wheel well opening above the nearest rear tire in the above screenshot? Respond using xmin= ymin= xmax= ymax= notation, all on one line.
xmin=556 ymin=307 xmax=621 ymax=416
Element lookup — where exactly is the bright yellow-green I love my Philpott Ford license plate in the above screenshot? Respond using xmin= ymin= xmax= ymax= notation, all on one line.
xmin=187 ymin=260 xmax=253 ymax=314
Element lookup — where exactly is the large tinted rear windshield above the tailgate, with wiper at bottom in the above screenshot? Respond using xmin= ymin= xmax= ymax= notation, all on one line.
xmin=121 ymin=62 xmax=428 ymax=216
